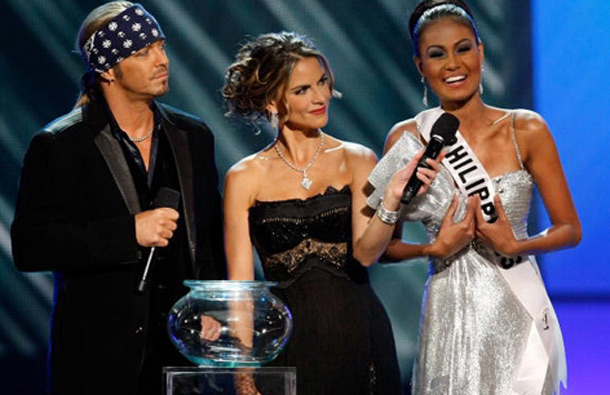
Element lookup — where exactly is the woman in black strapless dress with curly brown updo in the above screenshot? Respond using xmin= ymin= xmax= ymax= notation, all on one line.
xmin=223 ymin=32 xmax=438 ymax=395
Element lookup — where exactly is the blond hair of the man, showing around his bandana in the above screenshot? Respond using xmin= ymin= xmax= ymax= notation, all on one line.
xmin=74 ymin=1 xmax=133 ymax=108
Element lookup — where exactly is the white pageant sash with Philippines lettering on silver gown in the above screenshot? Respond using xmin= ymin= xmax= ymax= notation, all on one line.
xmin=415 ymin=107 xmax=566 ymax=394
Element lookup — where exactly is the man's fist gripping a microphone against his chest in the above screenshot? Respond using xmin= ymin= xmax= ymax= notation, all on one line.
xmin=136 ymin=187 xmax=180 ymax=292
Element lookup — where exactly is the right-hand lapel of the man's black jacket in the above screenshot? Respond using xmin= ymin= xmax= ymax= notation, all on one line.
xmin=161 ymin=114 xmax=197 ymax=262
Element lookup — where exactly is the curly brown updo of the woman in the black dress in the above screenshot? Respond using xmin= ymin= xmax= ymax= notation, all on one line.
xmin=222 ymin=32 xmax=334 ymax=123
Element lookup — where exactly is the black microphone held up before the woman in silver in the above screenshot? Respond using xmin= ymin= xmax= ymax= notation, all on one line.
xmin=400 ymin=112 xmax=460 ymax=204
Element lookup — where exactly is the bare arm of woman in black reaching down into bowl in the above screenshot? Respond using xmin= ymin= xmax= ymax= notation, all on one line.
xmin=223 ymin=159 xmax=258 ymax=280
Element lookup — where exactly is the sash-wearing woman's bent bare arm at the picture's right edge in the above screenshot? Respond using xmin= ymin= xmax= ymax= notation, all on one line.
xmin=477 ymin=111 xmax=582 ymax=256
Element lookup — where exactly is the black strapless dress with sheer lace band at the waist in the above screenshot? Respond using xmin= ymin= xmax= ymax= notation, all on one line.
xmin=249 ymin=186 xmax=401 ymax=395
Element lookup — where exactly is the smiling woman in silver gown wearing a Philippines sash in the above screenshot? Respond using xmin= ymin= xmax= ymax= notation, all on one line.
xmin=368 ymin=0 xmax=581 ymax=395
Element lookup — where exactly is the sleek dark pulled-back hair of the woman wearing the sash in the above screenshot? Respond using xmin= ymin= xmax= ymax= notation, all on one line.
xmin=409 ymin=0 xmax=481 ymax=56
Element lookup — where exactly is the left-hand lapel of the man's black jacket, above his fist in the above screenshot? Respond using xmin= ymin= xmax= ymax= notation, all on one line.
xmin=94 ymin=125 xmax=142 ymax=214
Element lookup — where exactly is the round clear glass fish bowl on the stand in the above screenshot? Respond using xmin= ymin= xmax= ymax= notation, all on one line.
xmin=167 ymin=280 xmax=292 ymax=367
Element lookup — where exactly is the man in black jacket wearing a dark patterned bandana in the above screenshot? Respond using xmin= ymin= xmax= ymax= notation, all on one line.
xmin=11 ymin=1 xmax=225 ymax=395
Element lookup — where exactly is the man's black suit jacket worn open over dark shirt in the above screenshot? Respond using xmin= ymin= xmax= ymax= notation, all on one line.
xmin=11 ymin=99 xmax=225 ymax=394
